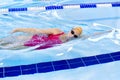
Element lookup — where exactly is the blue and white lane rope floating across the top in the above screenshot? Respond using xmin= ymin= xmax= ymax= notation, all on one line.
xmin=0 ymin=2 xmax=120 ymax=13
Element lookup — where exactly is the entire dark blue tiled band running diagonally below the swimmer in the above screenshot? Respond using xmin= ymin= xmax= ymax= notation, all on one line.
xmin=0 ymin=51 xmax=120 ymax=78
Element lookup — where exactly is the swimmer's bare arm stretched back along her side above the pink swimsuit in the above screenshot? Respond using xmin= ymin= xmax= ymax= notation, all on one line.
xmin=12 ymin=28 xmax=62 ymax=34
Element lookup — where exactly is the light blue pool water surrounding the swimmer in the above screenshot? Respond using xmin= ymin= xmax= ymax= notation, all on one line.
xmin=0 ymin=0 xmax=120 ymax=80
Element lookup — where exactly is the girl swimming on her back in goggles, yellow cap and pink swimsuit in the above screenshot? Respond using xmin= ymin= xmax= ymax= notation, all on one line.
xmin=0 ymin=27 xmax=82 ymax=49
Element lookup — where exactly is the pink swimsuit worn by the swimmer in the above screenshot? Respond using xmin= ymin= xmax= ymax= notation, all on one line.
xmin=24 ymin=32 xmax=64 ymax=49
